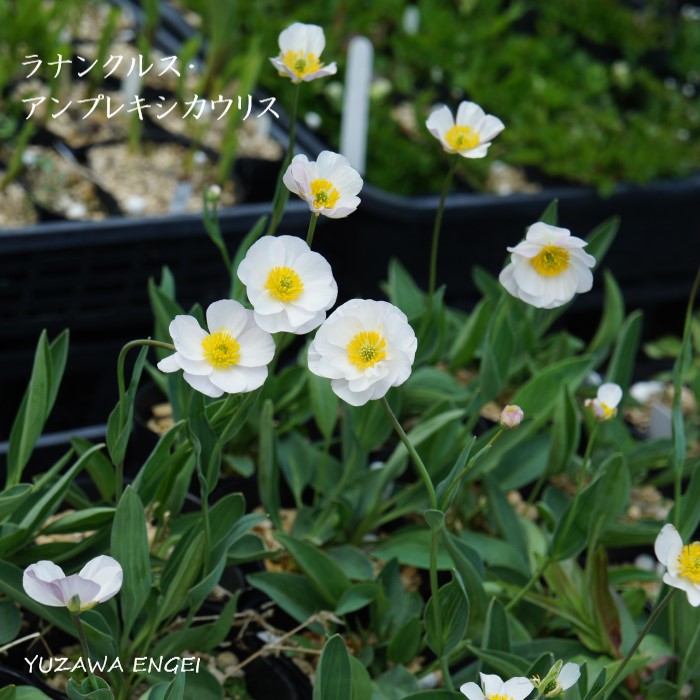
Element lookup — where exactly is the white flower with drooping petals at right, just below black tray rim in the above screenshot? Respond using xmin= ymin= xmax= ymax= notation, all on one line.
xmin=498 ymin=221 xmax=595 ymax=309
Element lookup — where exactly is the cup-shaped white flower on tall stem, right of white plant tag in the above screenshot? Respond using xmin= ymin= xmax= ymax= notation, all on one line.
xmin=425 ymin=102 xmax=505 ymax=158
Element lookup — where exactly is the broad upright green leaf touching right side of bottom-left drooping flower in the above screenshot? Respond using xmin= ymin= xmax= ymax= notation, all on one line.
xmin=112 ymin=486 xmax=151 ymax=638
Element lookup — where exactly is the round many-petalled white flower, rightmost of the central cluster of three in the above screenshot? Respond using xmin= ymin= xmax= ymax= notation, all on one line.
xmin=309 ymin=299 xmax=418 ymax=406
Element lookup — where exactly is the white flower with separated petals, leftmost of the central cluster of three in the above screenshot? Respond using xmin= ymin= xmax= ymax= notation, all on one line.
xmin=158 ymin=299 xmax=275 ymax=398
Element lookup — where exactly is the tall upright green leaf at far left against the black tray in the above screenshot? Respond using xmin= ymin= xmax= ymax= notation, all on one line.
xmin=5 ymin=331 xmax=68 ymax=487
